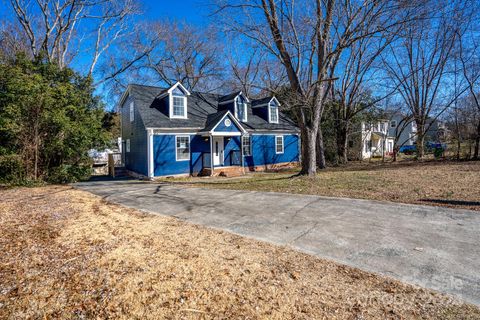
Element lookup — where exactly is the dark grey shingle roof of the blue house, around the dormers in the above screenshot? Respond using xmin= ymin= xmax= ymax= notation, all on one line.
xmin=129 ymin=84 xmax=298 ymax=131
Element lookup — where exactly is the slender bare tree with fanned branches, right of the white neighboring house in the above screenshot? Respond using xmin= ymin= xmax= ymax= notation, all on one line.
xmin=384 ymin=1 xmax=474 ymax=158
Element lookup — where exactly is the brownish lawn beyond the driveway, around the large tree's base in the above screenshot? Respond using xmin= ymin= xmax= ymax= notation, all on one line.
xmin=165 ymin=161 xmax=480 ymax=210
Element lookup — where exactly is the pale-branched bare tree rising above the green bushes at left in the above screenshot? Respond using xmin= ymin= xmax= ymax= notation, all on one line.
xmin=6 ymin=0 xmax=138 ymax=75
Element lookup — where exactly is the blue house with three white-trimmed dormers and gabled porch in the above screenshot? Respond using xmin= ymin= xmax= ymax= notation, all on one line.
xmin=119 ymin=82 xmax=300 ymax=178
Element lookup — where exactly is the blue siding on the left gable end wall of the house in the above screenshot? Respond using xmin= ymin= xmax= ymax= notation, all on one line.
xmin=121 ymin=97 xmax=148 ymax=175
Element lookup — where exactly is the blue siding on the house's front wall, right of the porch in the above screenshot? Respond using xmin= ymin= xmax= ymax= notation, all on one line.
xmin=245 ymin=134 xmax=299 ymax=167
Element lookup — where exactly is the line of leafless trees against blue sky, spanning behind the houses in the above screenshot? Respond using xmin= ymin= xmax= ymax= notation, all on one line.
xmin=0 ymin=0 xmax=480 ymax=181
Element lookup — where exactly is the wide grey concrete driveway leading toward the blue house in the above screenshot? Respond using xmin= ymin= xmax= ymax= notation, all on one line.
xmin=75 ymin=180 xmax=480 ymax=305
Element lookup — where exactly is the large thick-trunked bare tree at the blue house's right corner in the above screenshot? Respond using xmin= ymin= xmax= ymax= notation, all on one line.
xmin=217 ymin=0 xmax=422 ymax=176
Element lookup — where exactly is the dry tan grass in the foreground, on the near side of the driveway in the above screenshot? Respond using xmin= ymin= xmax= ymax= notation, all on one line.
xmin=0 ymin=187 xmax=480 ymax=319
